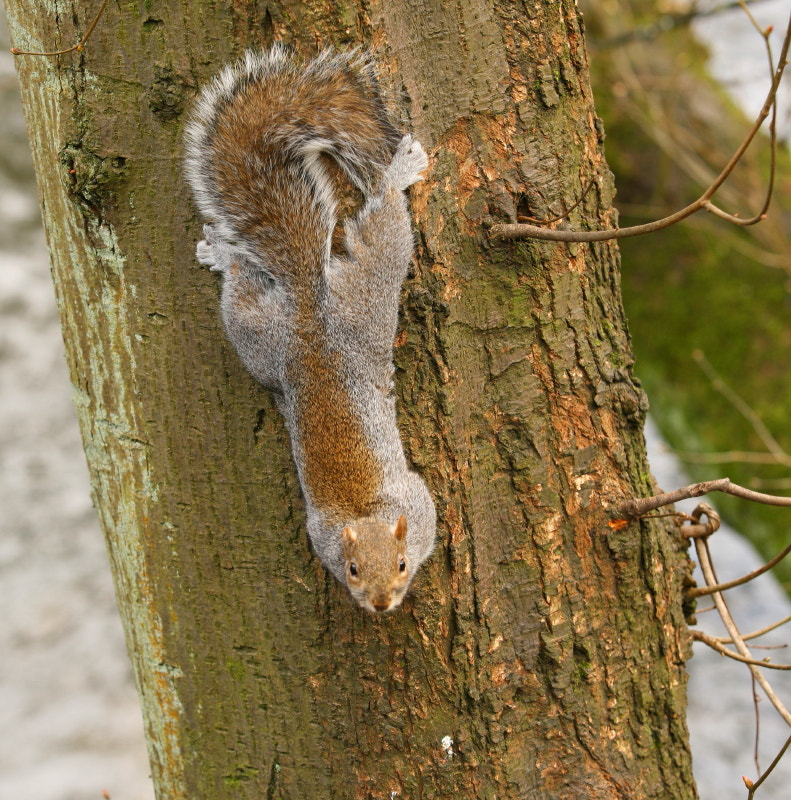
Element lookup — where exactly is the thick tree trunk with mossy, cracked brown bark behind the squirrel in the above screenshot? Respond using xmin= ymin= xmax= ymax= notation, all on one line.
xmin=8 ymin=0 xmax=695 ymax=800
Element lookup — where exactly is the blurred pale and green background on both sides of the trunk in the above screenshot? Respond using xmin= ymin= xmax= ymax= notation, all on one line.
xmin=0 ymin=0 xmax=791 ymax=800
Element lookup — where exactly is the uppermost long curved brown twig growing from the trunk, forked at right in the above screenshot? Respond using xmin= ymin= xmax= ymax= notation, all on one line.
xmin=490 ymin=10 xmax=791 ymax=242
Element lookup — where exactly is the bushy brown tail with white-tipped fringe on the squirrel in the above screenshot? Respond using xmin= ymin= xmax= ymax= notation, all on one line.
xmin=186 ymin=45 xmax=401 ymax=282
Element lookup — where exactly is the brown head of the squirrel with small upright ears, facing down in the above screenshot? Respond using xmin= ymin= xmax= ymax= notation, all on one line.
xmin=341 ymin=514 xmax=412 ymax=612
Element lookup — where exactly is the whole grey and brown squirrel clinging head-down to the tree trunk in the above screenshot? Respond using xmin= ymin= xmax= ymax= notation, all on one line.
xmin=186 ymin=45 xmax=436 ymax=611
